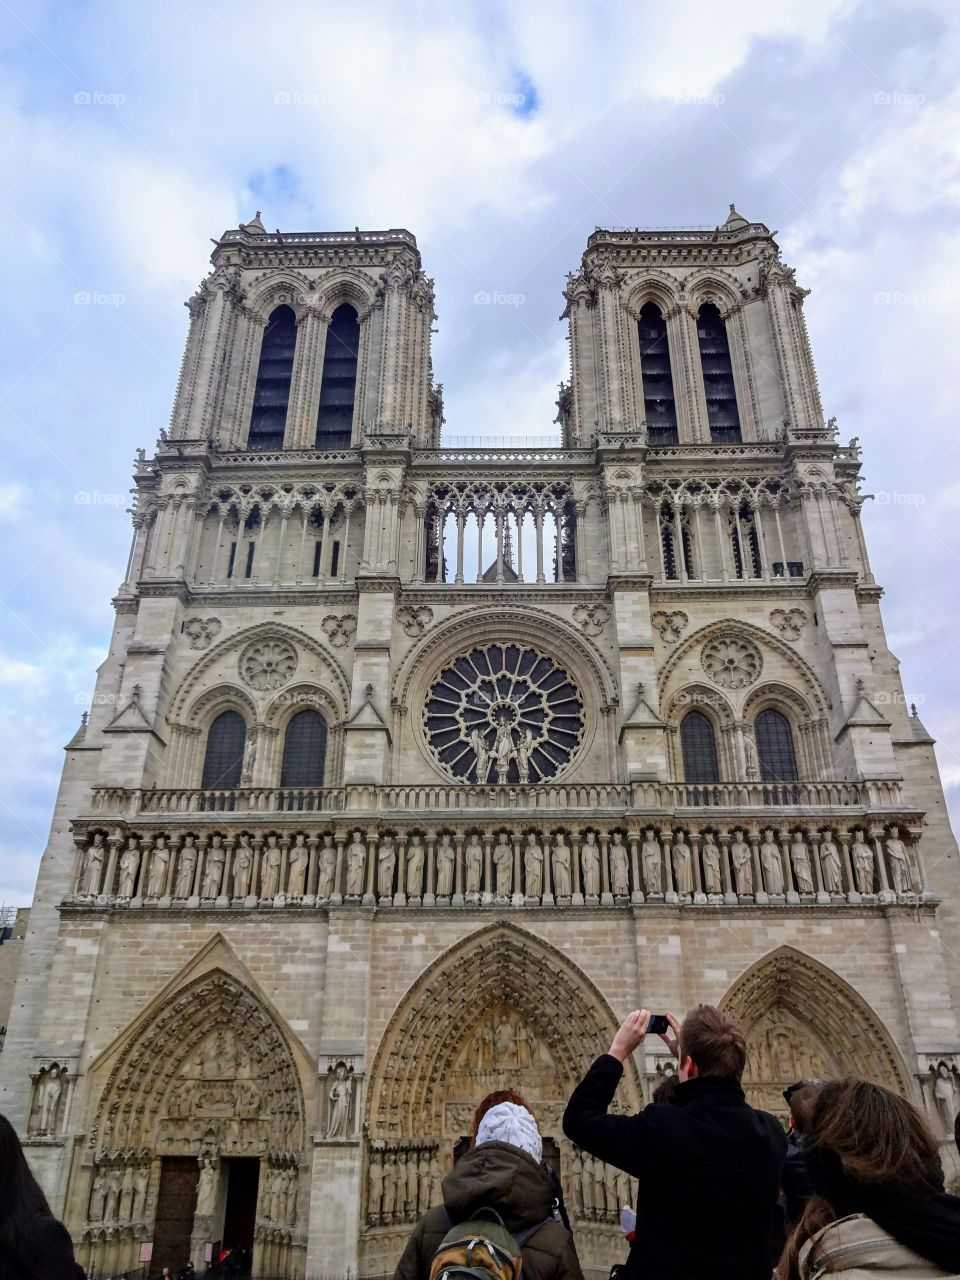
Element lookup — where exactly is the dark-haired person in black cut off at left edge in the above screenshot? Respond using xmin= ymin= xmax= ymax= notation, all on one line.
xmin=0 ymin=1116 xmax=83 ymax=1280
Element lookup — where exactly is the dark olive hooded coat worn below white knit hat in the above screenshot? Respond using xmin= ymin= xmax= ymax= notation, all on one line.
xmin=393 ymin=1142 xmax=584 ymax=1280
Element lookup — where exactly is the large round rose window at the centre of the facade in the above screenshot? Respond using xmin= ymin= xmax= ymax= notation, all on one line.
xmin=424 ymin=644 xmax=584 ymax=782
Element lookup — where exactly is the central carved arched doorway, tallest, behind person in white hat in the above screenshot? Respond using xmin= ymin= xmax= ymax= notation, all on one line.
xmin=360 ymin=924 xmax=640 ymax=1275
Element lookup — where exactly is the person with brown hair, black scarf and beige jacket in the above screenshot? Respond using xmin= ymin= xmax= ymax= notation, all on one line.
xmin=777 ymin=1076 xmax=960 ymax=1280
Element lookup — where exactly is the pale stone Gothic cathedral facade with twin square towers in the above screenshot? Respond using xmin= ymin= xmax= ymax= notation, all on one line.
xmin=0 ymin=207 xmax=960 ymax=1277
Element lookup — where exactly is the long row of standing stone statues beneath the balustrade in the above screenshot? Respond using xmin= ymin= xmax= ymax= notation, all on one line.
xmin=77 ymin=827 xmax=914 ymax=905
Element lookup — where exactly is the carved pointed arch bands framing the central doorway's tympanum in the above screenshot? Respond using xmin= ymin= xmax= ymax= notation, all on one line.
xmin=367 ymin=923 xmax=640 ymax=1137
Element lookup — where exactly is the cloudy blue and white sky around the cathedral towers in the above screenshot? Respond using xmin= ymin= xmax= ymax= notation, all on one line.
xmin=0 ymin=0 xmax=960 ymax=905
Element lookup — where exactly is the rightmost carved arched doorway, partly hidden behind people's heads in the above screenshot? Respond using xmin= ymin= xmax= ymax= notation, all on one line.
xmin=722 ymin=947 xmax=913 ymax=1123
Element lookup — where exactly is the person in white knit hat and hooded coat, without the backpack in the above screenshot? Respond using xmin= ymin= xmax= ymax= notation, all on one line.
xmin=394 ymin=1091 xmax=584 ymax=1280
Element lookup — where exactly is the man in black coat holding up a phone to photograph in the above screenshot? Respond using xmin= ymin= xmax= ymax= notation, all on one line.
xmin=563 ymin=1005 xmax=786 ymax=1280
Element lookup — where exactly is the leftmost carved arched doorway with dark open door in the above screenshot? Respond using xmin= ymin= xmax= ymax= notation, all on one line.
xmin=83 ymin=968 xmax=305 ymax=1276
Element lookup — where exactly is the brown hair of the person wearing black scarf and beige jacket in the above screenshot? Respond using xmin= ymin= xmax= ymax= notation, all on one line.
xmin=777 ymin=1076 xmax=937 ymax=1280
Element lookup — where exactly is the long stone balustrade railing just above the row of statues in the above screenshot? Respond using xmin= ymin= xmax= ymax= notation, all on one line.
xmin=88 ymin=778 xmax=914 ymax=818
